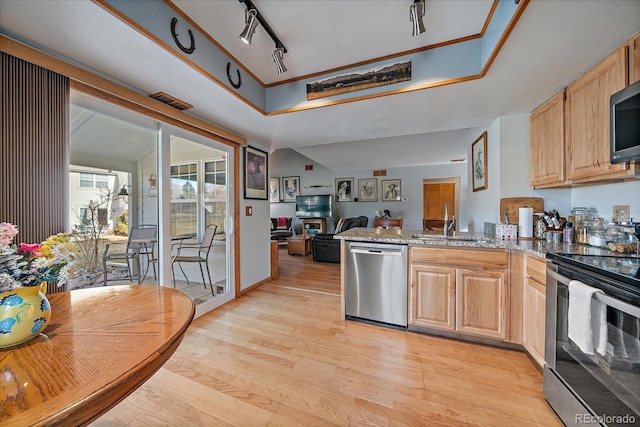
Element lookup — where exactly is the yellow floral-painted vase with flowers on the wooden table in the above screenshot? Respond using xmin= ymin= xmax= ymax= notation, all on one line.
xmin=0 ymin=222 xmax=69 ymax=349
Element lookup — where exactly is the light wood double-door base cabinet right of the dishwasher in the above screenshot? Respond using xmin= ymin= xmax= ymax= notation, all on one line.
xmin=409 ymin=247 xmax=509 ymax=341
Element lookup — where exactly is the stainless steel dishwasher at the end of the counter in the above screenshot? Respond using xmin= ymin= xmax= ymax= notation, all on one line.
xmin=345 ymin=242 xmax=407 ymax=328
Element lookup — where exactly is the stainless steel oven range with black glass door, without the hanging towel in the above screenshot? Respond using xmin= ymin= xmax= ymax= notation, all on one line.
xmin=543 ymin=254 xmax=640 ymax=426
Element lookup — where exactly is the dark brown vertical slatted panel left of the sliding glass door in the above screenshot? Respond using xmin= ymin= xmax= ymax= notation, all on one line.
xmin=0 ymin=53 xmax=69 ymax=243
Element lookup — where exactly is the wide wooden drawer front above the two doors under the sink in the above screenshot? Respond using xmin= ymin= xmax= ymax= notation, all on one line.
xmin=409 ymin=247 xmax=509 ymax=270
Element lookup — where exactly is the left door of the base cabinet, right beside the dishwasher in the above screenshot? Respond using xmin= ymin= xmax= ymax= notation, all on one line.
xmin=409 ymin=263 xmax=456 ymax=331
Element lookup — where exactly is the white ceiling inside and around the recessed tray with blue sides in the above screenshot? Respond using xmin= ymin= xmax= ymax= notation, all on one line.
xmin=0 ymin=0 xmax=640 ymax=172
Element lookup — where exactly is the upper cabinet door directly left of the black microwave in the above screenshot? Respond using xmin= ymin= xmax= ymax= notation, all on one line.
xmin=565 ymin=46 xmax=629 ymax=182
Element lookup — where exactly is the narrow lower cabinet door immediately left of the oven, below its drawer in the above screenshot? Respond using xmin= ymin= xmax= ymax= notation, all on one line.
xmin=522 ymin=278 xmax=547 ymax=367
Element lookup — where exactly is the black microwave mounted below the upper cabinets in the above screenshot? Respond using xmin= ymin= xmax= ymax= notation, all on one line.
xmin=610 ymin=81 xmax=640 ymax=163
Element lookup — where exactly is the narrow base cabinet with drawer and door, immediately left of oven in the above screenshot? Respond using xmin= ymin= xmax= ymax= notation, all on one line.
xmin=522 ymin=255 xmax=546 ymax=367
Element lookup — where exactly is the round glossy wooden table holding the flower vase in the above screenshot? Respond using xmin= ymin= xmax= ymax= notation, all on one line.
xmin=0 ymin=285 xmax=195 ymax=426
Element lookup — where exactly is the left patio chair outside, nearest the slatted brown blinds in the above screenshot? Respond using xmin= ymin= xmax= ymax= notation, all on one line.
xmin=102 ymin=224 xmax=158 ymax=286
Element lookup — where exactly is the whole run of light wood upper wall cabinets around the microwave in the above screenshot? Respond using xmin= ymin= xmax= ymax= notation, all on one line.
xmin=530 ymin=35 xmax=640 ymax=188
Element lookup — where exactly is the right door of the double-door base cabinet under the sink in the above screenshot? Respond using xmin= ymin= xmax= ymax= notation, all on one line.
xmin=456 ymin=269 xmax=509 ymax=341
